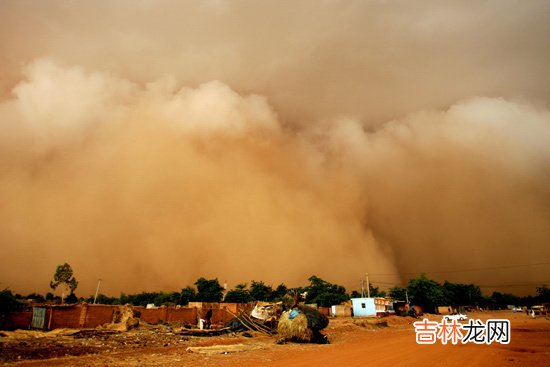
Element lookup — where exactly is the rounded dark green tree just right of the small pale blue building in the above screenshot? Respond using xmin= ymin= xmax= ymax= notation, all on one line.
xmin=407 ymin=274 xmax=448 ymax=312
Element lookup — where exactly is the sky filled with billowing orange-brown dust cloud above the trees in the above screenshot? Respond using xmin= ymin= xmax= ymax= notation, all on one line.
xmin=0 ymin=0 xmax=550 ymax=296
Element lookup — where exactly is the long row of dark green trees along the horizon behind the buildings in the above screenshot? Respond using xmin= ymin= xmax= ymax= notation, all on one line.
xmin=0 ymin=263 xmax=550 ymax=313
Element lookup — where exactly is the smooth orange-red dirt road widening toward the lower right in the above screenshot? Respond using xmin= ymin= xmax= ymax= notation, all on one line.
xmin=2 ymin=311 xmax=550 ymax=367
